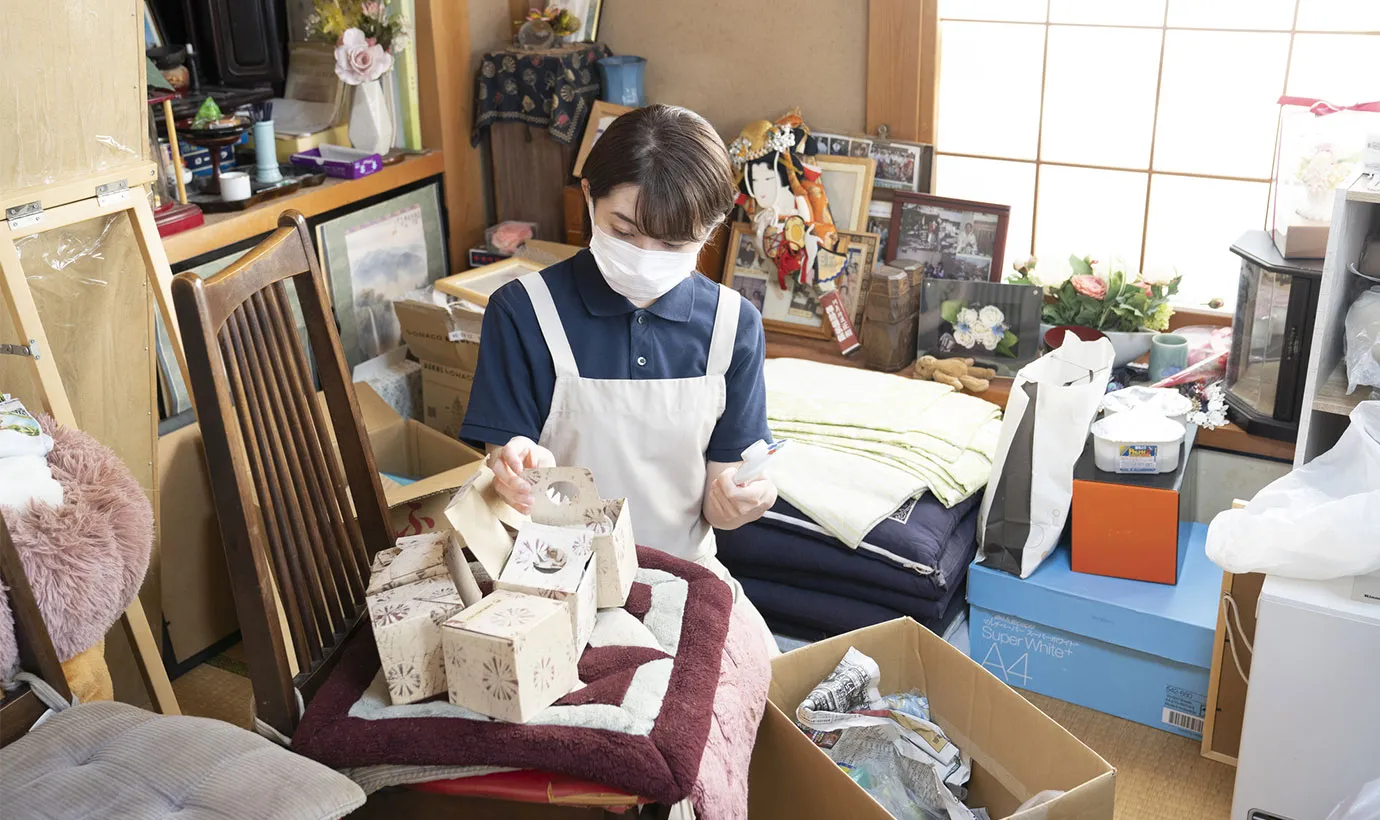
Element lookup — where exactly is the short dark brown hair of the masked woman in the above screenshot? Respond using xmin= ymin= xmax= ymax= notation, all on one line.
xmin=584 ymin=104 xmax=734 ymax=242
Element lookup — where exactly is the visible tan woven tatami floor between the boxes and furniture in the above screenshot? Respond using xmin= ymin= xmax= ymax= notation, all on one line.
xmin=173 ymin=647 xmax=1236 ymax=820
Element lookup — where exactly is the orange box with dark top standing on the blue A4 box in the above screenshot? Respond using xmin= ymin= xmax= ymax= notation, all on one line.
xmin=1071 ymin=427 xmax=1196 ymax=584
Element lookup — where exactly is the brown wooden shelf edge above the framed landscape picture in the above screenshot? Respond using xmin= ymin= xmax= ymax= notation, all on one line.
xmin=163 ymin=150 xmax=446 ymax=265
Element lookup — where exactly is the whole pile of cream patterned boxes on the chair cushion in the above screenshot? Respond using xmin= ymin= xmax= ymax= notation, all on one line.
xmin=370 ymin=468 xmax=638 ymax=722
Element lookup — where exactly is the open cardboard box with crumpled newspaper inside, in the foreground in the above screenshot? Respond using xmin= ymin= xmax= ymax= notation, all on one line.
xmin=772 ymin=618 xmax=1116 ymax=820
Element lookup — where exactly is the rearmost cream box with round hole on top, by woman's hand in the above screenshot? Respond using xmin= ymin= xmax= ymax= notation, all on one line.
xmin=519 ymin=467 xmax=638 ymax=609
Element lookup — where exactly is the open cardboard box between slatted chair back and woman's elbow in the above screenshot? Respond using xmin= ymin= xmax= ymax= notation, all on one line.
xmin=350 ymin=384 xmax=484 ymax=513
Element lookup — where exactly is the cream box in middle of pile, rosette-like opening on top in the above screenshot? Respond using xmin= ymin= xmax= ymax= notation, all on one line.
xmin=494 ymin=523 xmax=598 ymax=656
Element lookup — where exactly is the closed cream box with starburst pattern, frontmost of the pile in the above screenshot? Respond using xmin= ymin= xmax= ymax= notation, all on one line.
xmin=440 ymin=589 xmax=580 ymax=723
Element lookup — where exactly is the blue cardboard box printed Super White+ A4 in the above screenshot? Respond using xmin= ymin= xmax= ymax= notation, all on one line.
xmin=967 ymin=523 xmax=1221 ymax=740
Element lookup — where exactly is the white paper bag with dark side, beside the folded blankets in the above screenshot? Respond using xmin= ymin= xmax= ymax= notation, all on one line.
xmin=977 ymin=333 xmax=1115 ymax=578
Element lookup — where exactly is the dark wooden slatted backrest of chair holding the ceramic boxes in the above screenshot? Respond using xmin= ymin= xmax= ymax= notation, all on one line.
xmin=173 ymin=211 xmax=393 ymax=734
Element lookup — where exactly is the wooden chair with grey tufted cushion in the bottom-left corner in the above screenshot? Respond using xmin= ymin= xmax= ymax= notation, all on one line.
xmin=0 ymin=510 xmax=364 ymax=820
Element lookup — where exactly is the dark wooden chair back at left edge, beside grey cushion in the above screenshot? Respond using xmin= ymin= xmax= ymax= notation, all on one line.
xmin=0 ymin=516 xmax=72 ymax=747
